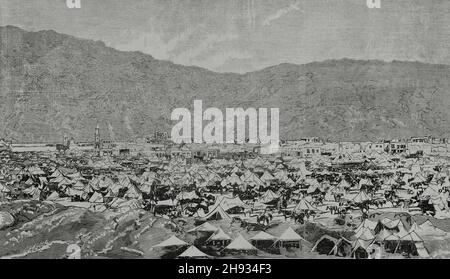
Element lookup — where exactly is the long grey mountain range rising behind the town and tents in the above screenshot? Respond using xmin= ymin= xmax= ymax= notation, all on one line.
xmin=0 ymin=26 xmax=450 ymax=144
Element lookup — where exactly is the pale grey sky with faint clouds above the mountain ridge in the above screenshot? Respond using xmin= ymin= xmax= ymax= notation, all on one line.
xmin=0 ymin=0 xmax=450 ymax=73
